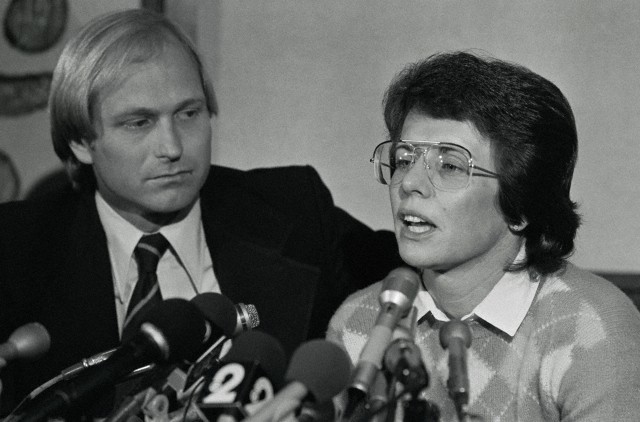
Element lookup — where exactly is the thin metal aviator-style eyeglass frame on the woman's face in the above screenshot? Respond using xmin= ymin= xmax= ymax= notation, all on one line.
xmin=369 ymin=139 xmax=500 ymax=191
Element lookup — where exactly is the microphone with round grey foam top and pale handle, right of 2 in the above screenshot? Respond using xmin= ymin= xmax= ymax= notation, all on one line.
xmin=245 ymin=339 xmax=351 ymax=422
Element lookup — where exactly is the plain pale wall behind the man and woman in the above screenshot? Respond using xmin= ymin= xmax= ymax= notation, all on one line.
xmin=0 ymin=0 xmax=640 ymax=272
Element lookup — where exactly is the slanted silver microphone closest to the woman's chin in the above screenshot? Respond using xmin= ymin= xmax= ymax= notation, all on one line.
xmin=346 ymin=267 xmax=420 ymax=416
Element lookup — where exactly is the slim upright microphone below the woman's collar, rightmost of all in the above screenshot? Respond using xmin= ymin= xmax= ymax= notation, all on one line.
xmin=440 ymin=320 xmax=471 ymax=418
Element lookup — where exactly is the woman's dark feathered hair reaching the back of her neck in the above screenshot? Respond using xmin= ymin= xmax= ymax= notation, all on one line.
xmin=383 ymin=52 xmax=580 ymax=275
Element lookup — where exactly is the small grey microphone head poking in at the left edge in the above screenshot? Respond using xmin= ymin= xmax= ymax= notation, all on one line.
xmin=0 ymin=322 xmax=51 ymax=362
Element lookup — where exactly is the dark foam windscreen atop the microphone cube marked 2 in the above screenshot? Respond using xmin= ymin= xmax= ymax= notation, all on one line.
xmin=221 ymin=331 xmax=287 ymax=390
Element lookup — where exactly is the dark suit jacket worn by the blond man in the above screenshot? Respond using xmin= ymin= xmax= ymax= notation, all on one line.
xmin=0 ymin=166 xmax=400 ymax=413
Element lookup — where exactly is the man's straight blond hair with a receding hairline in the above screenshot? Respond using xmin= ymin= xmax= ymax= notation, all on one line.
xmin=49 ymin=9 xmax=218 ymax=190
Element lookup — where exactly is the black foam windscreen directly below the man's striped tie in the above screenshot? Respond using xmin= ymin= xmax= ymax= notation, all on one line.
xmin=140 ymin=298 xmax=207 ymax=362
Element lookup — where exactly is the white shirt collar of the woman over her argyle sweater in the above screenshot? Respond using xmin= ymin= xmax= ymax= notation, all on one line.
xmin=415 ymin=244 xmax=538 ymax=336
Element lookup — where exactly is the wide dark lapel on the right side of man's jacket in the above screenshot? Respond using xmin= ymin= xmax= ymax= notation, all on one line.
xmin=201 ymin=167 xmax=320 ymax=354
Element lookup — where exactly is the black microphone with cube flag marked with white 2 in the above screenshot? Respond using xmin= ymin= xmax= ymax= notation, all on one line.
xmin=195 ymin=331 xmax=286 ymax=421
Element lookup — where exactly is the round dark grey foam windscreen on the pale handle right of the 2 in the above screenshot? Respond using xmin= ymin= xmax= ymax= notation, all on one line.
xmin=285 ymin=339 xmax=351 ymax=403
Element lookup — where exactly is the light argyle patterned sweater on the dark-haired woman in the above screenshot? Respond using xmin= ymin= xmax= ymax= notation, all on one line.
xmin=327 ymin=264 xmax=640 ymax=422
